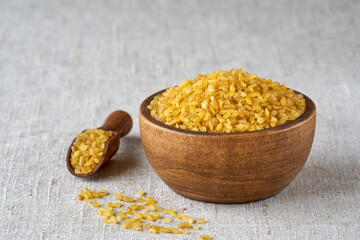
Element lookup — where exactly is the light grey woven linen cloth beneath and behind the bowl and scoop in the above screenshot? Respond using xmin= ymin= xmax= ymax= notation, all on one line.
xmin=0 ymin=0 xmax=360 ymax=239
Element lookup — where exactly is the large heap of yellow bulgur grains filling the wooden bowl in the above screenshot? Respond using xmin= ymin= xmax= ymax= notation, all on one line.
xmin=147 ymin=69 xmax=306 ymax=133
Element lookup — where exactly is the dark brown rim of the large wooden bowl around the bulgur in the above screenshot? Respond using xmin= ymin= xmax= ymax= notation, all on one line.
xmin=139 ymin=88 xmax=316 ymax=136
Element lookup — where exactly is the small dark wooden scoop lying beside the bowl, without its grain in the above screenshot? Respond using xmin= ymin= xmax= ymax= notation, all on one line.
xmin=66 ymin=111 xmax=132 ymax=178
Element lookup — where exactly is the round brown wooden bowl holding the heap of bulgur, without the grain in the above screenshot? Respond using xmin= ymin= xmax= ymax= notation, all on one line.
xmin=139 ymin=90 xmax=316 ymax=203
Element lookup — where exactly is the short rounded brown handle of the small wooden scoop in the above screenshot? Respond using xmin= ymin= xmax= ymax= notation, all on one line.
xmin=100 ymin=110 xmax=133 ymax=138
